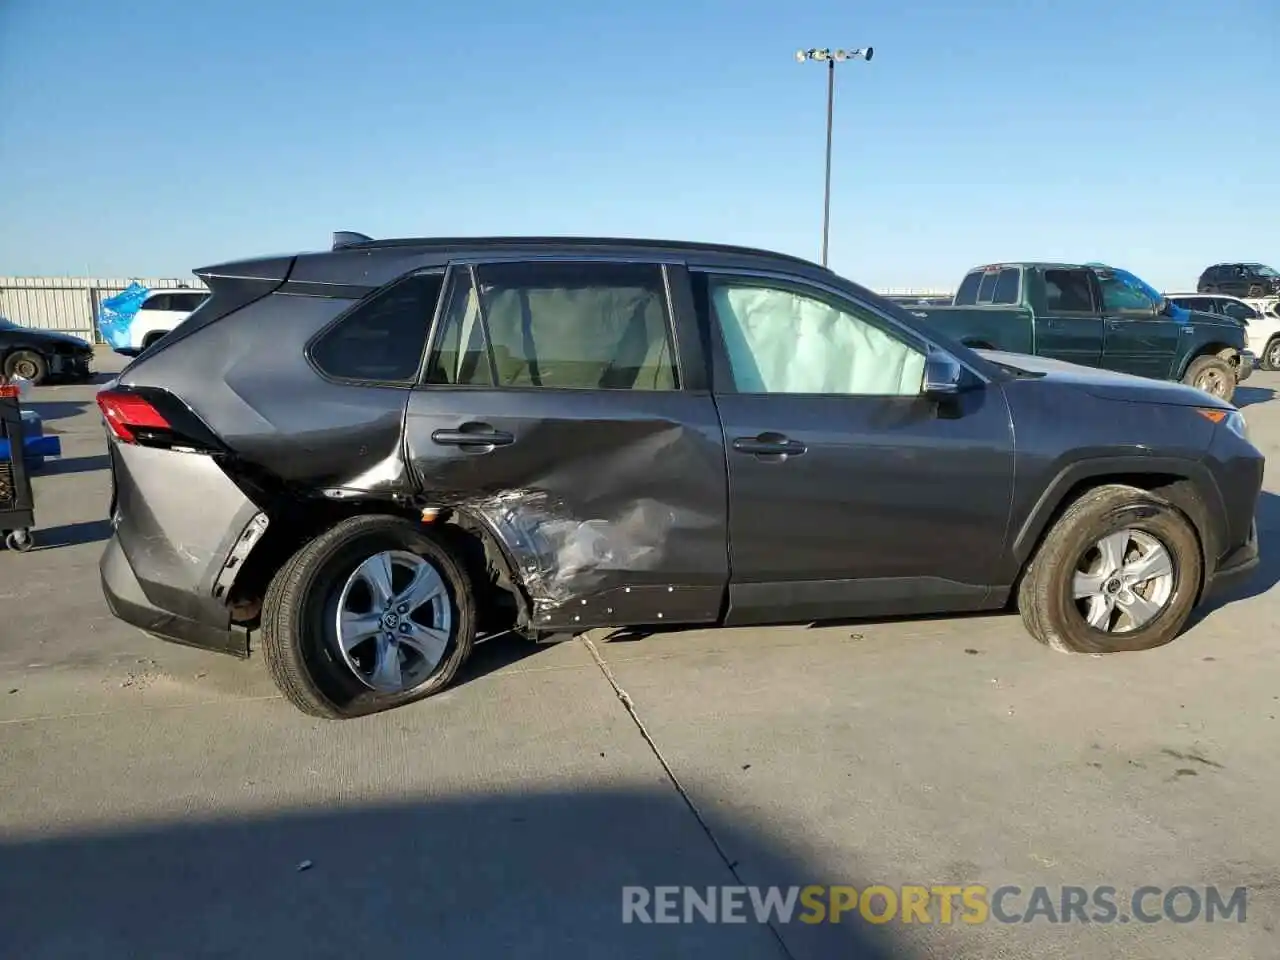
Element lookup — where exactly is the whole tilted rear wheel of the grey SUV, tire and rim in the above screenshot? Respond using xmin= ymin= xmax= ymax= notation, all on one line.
xmin=262 ymin=515 xmax=476 ymax=719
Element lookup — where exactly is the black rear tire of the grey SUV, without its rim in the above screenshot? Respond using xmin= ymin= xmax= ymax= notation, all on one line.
xmin=261 ymin=515 xmax=476 ymax=719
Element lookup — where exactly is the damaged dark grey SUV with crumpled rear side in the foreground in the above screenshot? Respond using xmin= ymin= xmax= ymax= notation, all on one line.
xmin=97 ymin=234 xmax=1263 ymax=718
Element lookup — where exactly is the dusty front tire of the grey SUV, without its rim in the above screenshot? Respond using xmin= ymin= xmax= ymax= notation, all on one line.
xmin=1018 ymin=484 xmax=1204 ymax=653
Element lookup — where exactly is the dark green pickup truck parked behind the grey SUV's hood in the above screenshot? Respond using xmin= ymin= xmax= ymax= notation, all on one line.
xmin=904 ymin=264 xmax=1256 ymax=401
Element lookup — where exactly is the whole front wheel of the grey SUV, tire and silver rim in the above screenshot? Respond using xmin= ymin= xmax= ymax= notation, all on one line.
xmin=1018 ymin=484 xmax=1203 ymax=653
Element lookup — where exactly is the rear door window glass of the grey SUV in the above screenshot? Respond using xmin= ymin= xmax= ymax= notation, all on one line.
xmin=428 ymin=261 xmax=680 ymax=390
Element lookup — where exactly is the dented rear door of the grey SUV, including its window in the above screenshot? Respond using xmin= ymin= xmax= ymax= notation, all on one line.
xmin=404 ymin=260 xmax=728 ymax=630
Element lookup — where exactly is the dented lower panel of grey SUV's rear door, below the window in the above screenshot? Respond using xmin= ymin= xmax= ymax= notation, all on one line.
xmin=406 ymin=387 xmax=728 ymax=630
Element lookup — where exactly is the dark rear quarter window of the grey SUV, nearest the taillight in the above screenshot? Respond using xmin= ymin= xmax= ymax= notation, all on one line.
xmin=311 ymin=274 xmax=442 ymax=383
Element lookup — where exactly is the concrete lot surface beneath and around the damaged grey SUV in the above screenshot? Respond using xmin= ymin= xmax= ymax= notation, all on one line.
xmin=0 ymin=355 xmax=1280 ymax=960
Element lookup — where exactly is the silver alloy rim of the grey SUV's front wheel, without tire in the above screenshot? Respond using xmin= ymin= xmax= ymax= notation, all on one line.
xmin=1071 ymin=529 xmax=1175 ymax=634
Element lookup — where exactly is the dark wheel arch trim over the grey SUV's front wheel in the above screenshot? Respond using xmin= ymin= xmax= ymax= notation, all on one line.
xmin=1012 ymin=456 xmax=1226 ymax=580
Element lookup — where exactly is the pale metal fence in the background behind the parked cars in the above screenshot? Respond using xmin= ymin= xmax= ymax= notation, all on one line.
xmin=0 ymin=276 xmax=951 ymax=343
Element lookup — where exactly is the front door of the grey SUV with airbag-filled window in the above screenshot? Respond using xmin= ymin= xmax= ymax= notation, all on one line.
xmin=692 ymin=271 xmax=1014 ymax=632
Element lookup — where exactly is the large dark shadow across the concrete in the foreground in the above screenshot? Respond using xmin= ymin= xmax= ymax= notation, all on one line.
xmin=0 ymin=783 xmax=916 ymax=960
